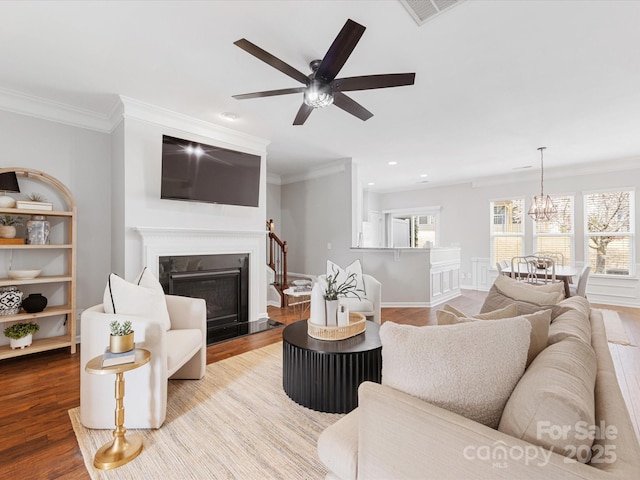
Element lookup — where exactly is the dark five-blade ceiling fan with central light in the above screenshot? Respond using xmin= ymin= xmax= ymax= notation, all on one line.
xmin=233 ymin=20 xmax=416 ymax=125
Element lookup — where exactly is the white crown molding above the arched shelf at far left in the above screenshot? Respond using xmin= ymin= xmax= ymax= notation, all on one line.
xmin=0 ymin=87 xmax=113 ymax=133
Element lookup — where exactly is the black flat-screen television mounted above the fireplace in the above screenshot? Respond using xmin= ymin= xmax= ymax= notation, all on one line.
xmin=160 ymin=135 xmax=260 ymax=207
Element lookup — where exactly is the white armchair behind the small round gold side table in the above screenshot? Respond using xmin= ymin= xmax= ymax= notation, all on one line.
xmin=80 ymin=295 xmax=207 ymax=429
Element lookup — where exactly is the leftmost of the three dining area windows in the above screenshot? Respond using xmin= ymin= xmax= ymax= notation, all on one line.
xmin=490 ymin=198 xmax=524 ymax=265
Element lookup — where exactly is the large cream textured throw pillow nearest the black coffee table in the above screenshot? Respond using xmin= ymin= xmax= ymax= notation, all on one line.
xmin=380 ymin=318 xmax=531 ymax=428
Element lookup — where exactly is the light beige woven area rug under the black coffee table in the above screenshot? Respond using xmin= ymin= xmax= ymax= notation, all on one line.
xmin=69 ymin=342 xmax=342 ymax=480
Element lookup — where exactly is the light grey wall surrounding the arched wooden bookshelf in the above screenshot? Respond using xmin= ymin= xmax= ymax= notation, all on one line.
xmin=0 ymin=111 xmax=112 ymax=336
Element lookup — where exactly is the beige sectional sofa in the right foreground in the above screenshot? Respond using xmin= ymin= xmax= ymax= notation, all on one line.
xmin=318 ymin=281 xmax=640 ymax=480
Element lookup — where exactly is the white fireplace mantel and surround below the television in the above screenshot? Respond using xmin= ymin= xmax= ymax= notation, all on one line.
xmin=133 ymin=227 xmax=267 ymax=321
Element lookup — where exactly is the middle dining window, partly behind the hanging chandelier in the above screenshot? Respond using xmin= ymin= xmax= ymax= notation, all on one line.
xmin=533 ymin=195 xmax=574 ymax=265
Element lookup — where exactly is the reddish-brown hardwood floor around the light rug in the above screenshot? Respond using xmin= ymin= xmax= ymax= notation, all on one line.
xmin=0 ymin=291 xmax=640 ymax=480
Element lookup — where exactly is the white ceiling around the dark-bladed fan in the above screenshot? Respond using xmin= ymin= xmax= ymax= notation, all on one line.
xmin=0 ymin=0 xmax=640 ymax=191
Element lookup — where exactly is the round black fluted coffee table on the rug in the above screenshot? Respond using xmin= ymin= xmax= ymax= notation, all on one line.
xmin=282 ymin=320 xmax=382 ymax=413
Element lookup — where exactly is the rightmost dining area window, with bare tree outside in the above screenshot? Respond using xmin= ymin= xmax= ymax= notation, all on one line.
xmin=584 ymin=190 xmax=635 ymax=275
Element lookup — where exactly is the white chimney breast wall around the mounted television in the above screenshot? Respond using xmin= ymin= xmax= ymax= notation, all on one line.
xmin=112 ymin=98 xmax=268 ymax=320
